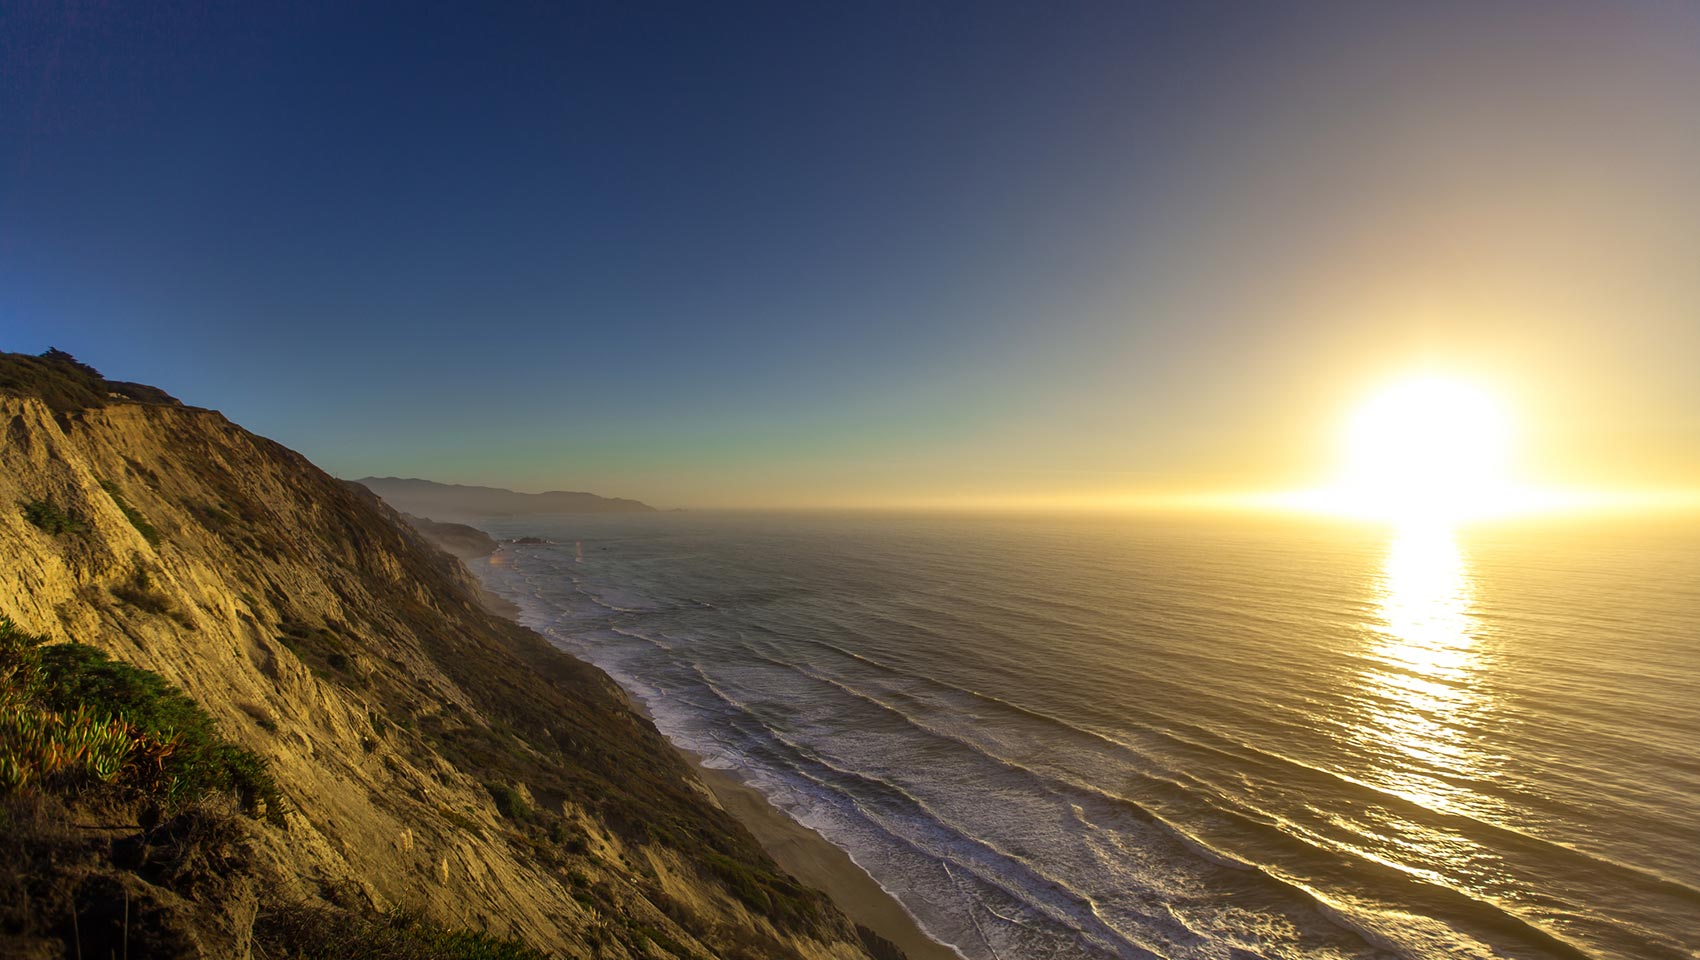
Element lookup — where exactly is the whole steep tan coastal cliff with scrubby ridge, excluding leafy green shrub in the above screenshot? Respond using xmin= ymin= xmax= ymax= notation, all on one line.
xmin=0 ymin=355 xmax=899 ymax=960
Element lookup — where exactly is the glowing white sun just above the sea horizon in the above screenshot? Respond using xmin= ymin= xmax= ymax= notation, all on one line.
xmin=1331 ymin=376 xmax=1511 ymax=527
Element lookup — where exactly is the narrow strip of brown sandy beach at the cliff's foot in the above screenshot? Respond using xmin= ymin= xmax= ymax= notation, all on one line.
xmin=468 ymin=557 xmax=962 ymax=960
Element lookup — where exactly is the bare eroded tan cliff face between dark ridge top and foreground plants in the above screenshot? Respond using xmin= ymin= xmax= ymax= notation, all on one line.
xmin=0 ymin=392 xmax=890 ymax=960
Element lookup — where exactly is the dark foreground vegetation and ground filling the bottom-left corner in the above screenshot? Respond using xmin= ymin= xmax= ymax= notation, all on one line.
xmin=0 ymin=617 xmax=546 ymax=960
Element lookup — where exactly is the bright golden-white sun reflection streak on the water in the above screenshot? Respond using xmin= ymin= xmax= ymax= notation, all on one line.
xmin=1360 ymin=527 xmax=1486 ymax=809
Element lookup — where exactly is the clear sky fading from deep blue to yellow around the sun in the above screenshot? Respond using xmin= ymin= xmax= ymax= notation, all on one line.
xmin=0 ymin=2 xmax=1700 ymax=506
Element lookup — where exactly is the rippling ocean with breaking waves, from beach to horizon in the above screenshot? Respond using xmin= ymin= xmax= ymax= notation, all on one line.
xmin=479 ymin=513 xmax=1700 ymax=960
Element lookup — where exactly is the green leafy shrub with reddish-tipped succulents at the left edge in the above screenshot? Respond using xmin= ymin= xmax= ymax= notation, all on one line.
xmin=0 ymin=617 xmax=282 ymax=822
